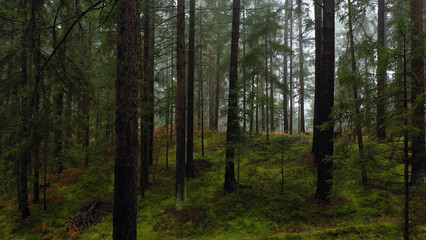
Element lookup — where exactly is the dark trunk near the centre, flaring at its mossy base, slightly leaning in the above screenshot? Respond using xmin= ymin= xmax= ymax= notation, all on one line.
xmin=223 ymin=0 xmax=240 ymax=194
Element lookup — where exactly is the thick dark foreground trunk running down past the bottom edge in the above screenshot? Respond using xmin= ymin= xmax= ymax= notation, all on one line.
xmin=113 ymin=0 xmax=140 ymax=237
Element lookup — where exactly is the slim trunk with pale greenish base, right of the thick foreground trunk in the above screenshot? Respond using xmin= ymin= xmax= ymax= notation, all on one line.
xmin=176 ymin=0 xmax=185 ymax=210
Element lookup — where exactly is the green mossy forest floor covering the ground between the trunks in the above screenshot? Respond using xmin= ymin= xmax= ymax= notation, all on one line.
xmin=0 ymin=132 xmax=426 ymax=240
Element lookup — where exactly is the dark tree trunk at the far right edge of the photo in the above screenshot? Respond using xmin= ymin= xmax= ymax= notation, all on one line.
xmin=410 ymin=0 xmax=426 ymax=185
